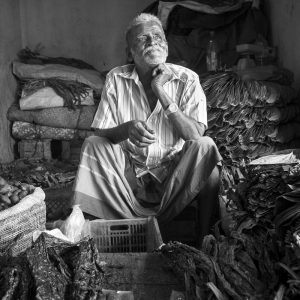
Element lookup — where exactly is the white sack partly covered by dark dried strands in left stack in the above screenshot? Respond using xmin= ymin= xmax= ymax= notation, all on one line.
xmin=20 ymin=87 xmax=95 ymax=110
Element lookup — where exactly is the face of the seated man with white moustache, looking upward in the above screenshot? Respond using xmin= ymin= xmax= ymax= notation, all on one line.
xmin=128 ymin=21 xmax=168 ymax=66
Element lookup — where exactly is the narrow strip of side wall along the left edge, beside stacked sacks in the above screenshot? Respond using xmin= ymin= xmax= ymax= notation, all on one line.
xmin=0 ymin=0 xmax=21 ymax=163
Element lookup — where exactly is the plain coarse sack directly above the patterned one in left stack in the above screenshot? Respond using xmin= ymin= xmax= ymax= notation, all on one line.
xmin=7 ymin=104 xmax=97 ymax=130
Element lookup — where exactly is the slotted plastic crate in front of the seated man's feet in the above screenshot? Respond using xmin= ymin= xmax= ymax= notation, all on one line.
xmin=85 ymin=217 xmax=163 ymax=253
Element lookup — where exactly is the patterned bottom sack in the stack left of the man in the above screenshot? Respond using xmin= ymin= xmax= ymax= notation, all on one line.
xmin=12 ymin=121 xmax=94 ymax=140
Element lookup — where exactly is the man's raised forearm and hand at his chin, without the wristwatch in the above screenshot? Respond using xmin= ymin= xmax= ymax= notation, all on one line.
xmin=151 ymin=65 xmax=205 ymax=140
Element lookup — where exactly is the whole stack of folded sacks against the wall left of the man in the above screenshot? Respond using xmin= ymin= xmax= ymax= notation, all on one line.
xmin=7 ymin=49 xmax=105 ymax=158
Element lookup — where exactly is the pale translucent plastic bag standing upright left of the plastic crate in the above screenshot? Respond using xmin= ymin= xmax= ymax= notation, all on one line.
xmin=60 ymin=204 xmax=85 ymax=243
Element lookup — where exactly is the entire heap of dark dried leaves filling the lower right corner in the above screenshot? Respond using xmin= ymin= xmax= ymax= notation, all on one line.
xmin=161 ymin=156 xmax=300 ymax=300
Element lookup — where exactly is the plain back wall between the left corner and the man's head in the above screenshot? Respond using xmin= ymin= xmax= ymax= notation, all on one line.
xmin=20 ymin=0 xmax=154 ymax=71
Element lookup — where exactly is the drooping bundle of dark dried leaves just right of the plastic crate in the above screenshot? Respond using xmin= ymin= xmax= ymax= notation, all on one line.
xmin=161 ymin=235 xmax=277 ymax=300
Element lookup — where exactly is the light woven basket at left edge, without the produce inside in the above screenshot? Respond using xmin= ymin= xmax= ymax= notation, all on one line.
xmin=0 ymin=187 xmax=46 ymax=256
